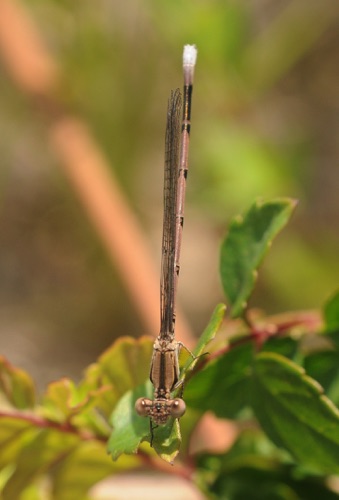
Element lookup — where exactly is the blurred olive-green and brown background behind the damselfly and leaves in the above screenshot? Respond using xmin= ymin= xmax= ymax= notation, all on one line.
xmin=0 ymin=0 xmax=339 ymax=389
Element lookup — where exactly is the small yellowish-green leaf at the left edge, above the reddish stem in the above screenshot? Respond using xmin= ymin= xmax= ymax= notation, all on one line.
xmin=0 ymin=356 xmax=35 ymax=410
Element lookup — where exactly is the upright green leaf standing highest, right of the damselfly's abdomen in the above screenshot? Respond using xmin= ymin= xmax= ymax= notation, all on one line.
xmin=220 ymin=198 xmax=296 ymax=318
